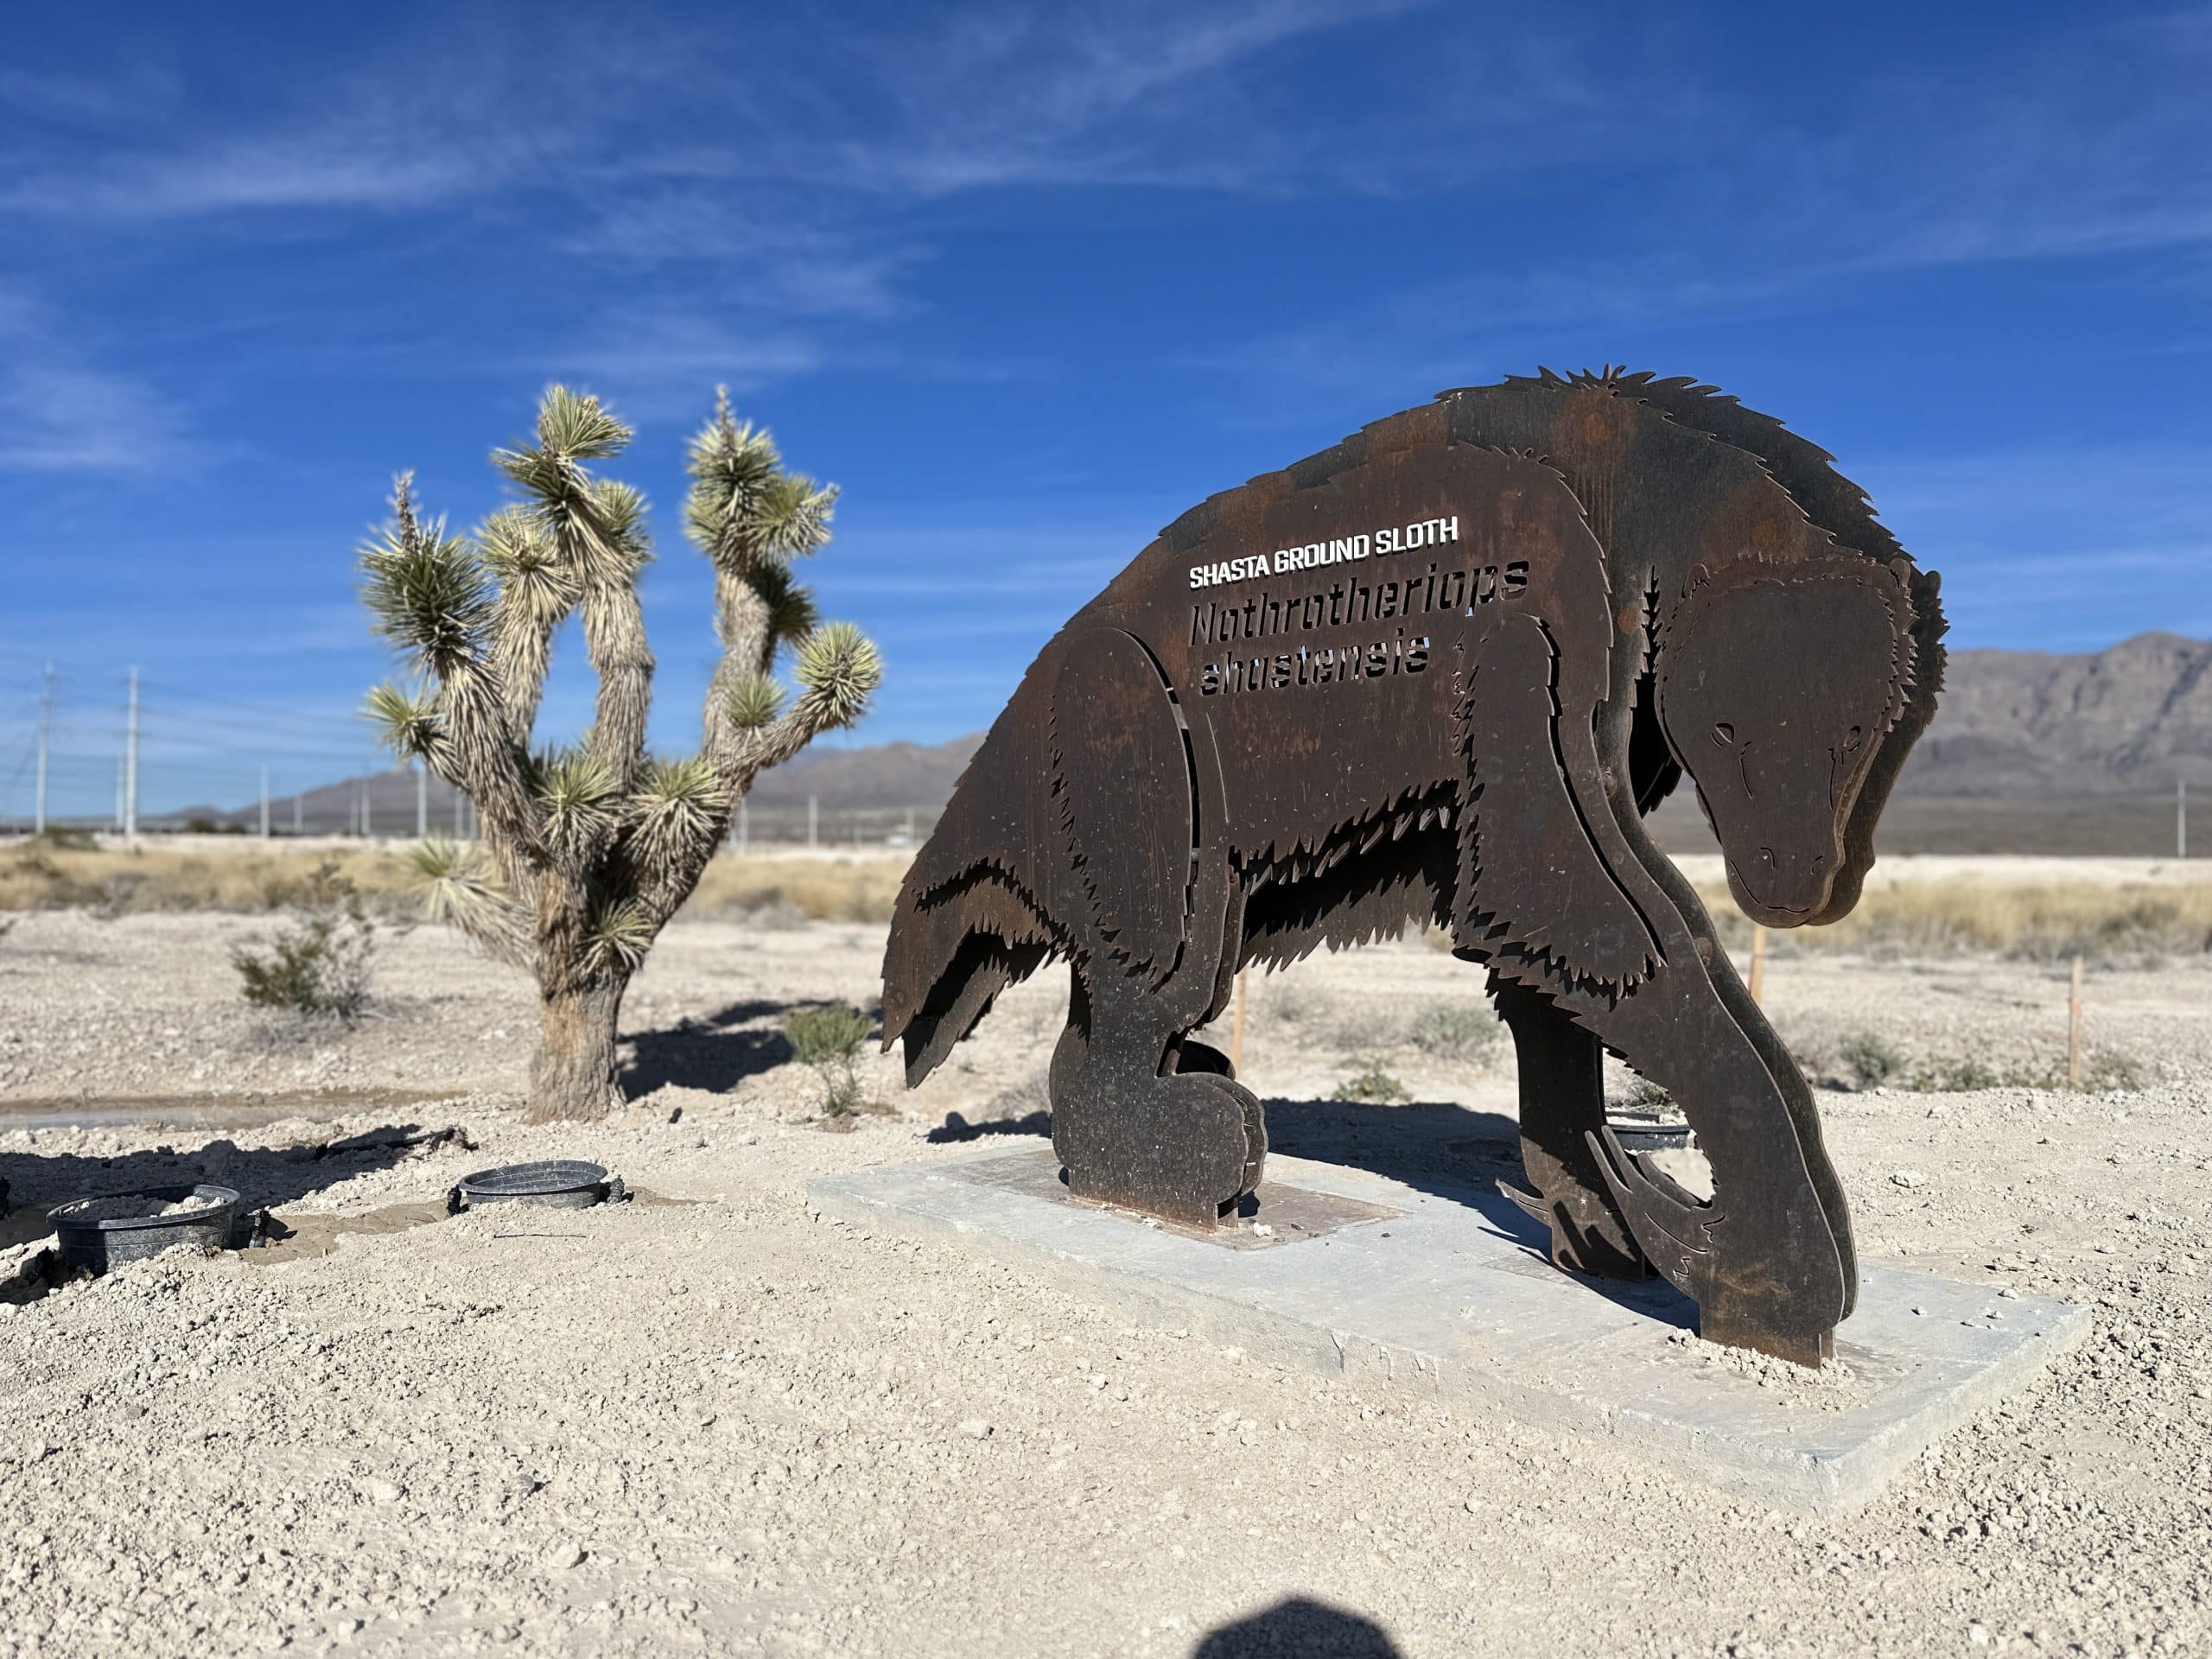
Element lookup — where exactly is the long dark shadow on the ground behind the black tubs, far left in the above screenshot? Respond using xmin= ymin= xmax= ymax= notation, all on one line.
xmin=0 ymin=1123 xmax=471 ymax=1245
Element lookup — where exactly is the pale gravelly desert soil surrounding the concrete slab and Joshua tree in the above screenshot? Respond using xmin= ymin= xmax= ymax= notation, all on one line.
xmin=0 ymin=916 xmax=2212 ymax=1659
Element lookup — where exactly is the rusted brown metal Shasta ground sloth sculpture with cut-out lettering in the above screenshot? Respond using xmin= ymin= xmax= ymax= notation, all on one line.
xmin=882 ymin=372 xmax=1944 ymax=1365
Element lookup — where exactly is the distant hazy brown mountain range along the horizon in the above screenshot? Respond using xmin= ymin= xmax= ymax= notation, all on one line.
xmin=163 ymin=632 xmax=2212 ymax=852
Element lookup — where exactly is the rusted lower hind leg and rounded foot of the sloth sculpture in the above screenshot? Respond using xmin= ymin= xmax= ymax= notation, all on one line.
xmin=1051 ymin=963 xmax=1268 ymax=1228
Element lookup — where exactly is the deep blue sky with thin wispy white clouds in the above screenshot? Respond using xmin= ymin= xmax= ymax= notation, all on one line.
xmin=0 ymin=0 xmax=2212 ymax=814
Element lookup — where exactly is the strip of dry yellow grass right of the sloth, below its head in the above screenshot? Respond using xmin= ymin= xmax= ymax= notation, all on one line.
xmin=1699 ymin=880 xmax=2212 ymax=963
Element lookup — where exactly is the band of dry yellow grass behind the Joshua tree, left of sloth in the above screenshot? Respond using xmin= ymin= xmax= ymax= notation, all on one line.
xmin=0 ymin=842 xmax=907 ymax=938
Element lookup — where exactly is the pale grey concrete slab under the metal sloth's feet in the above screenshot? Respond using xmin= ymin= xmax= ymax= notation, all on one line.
xmin=810 ymin=1146 xmax=2090 ymax=1513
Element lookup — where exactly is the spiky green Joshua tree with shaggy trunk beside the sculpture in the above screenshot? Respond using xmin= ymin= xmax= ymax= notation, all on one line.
xmin=360 ymin=387 xmax=882 ymax=1119
